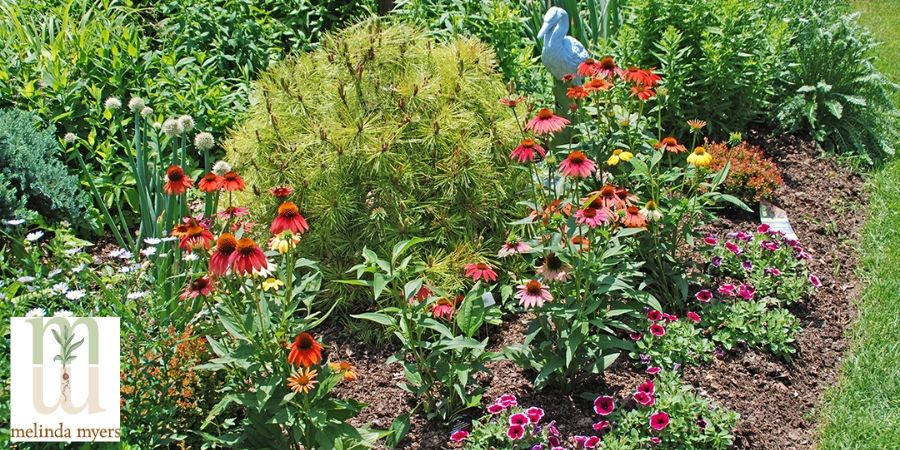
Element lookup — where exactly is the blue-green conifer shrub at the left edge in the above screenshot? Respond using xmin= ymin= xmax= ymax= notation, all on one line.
xmin=0 ymin=109 xmax=86 ymax=223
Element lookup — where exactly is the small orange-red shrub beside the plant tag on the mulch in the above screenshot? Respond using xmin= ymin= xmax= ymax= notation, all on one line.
xmin=706 ymin=142 xmax=784 ymax=203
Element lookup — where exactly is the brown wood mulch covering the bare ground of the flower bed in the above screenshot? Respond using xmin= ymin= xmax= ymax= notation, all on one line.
xmin=327 ymin=129 xmax=866 ymax=450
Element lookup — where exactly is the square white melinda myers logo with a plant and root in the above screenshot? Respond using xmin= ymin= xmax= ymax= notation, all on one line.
xmin=10 ymin=317 xmax=119 ymax=442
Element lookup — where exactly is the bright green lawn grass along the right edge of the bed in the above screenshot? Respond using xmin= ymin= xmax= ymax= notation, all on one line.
xmin=819 ymin=0 xmax=900 ymax=449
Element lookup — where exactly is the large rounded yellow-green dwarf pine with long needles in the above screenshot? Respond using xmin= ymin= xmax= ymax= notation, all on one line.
xmin=224 ymin=19 xmax=526 ymax=310
